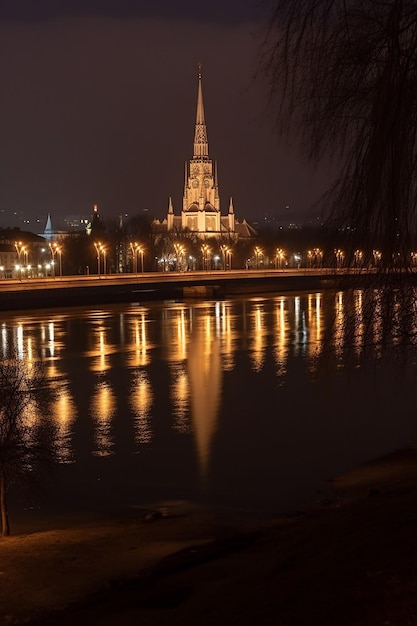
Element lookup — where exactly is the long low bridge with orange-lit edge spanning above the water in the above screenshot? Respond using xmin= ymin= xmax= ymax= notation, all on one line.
xmin=0 ymin=268 xmax=380 ymax=311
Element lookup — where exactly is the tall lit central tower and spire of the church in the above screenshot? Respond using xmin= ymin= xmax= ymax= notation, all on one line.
xmin=181 ymin=63 xmax=222 ymax=235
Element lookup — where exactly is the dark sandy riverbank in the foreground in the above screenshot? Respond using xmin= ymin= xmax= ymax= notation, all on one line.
xmin=4 ymin=447 xmax=417 ymax=626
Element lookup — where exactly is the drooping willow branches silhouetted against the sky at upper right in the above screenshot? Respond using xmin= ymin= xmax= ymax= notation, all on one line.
xmin=260 ymin=0 xmax=417 ymax=272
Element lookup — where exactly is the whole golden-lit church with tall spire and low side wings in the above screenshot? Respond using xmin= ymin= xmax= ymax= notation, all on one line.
xmin=153 ymin=64 xmax=256 ymax=240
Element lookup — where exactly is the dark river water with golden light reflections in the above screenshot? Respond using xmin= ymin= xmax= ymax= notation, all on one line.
xmin=0 ymin=291 xmax=417 ymax=523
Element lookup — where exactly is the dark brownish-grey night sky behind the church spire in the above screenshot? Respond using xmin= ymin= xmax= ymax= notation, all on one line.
xmin=0 ymin=0 xmax=334 ymax=230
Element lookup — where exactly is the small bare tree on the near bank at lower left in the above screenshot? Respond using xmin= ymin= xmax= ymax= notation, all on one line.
xmin=0 ymin=356 xmax=56 ymax=536
